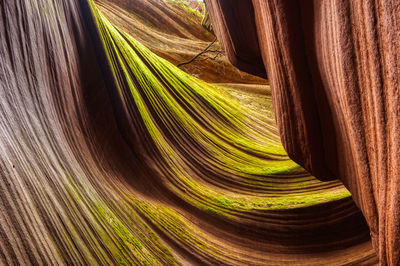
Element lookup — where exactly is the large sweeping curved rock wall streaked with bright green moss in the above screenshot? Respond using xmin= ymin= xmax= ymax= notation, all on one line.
xmin=0 ymin=0 xmax=377 ymax=265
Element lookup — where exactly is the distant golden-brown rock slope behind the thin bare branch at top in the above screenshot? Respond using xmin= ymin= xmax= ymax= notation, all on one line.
xmin=92 ymin=0 xmax=265 ymax=84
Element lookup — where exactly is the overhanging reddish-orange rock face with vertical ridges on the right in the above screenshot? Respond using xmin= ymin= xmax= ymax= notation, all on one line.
xmin=206 ymin=0 xmax=400 ymax=265
